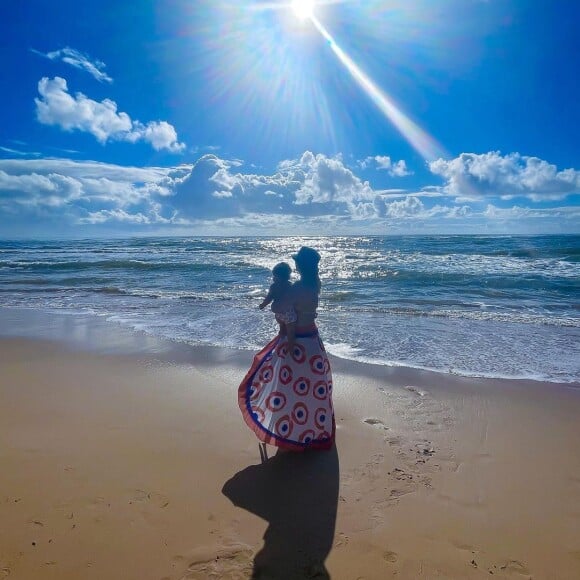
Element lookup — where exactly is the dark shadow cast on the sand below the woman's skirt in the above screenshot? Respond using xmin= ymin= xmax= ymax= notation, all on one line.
xmin=222 ymin=446 xmax=339 ymax=580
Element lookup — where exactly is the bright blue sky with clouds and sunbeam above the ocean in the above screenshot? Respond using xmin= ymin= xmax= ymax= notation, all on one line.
xmin=0 ymin=0 xmax=580 ymax=237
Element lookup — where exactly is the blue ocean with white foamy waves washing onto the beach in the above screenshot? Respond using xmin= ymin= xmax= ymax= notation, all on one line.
xmin=0 ymin=236 xmax=580 ymax=383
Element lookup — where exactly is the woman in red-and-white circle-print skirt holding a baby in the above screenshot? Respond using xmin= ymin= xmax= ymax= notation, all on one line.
xmin=238 ymin=246 xmax=335 ymax=451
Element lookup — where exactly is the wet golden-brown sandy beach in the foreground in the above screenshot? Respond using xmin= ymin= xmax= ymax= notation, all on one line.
xmin=0 ymin=324 xmax=580 ymax=580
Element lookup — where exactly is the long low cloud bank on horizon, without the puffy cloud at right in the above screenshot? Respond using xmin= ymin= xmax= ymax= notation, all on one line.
xmin=0 ymin=151 xmax=580 ymax=234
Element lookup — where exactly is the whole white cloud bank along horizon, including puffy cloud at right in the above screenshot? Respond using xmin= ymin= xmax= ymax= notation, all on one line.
xmin=0 ymin=151 xmax=580 ymax=233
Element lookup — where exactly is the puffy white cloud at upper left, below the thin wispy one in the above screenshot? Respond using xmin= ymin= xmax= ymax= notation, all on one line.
xmin=35 ymin=77 xmax=185 ymax=153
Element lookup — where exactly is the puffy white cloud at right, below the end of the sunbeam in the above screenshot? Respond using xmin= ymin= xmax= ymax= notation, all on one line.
xmin=429 ymin=151 xmax=580 ymax=201
